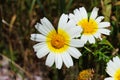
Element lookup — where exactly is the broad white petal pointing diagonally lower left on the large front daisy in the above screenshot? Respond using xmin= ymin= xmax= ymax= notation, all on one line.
xmin=36 ymin=46 xmax=50 ymax=58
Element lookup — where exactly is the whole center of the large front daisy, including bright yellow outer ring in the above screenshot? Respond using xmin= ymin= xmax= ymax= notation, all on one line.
xmin=46 ymin=29 xmax=70 ymax=53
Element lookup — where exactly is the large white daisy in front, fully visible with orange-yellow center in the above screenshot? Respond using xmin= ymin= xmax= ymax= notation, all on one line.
xmin=31 ymin=14 xmax=84 ymax=69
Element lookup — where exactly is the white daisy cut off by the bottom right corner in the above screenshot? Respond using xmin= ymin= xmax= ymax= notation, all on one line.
xmin=104 ymin=56 xmax=120 ymax=80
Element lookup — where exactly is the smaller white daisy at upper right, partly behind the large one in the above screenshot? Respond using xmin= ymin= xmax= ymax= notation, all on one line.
xmin=69 ymin=7 xmax=110 ymax=43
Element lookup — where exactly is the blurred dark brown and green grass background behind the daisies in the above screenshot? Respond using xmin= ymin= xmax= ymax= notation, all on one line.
xmin=0 ymin=0 xmax=120 ymax=80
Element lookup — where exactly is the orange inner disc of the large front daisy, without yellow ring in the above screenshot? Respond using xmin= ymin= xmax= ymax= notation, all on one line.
xmin=51 ymin=34 xmax=65 ymax=49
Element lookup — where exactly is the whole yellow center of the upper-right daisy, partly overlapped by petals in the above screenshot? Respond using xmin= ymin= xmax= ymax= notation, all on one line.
xmin=77 ymin=19 xmax=98 ymax=35
